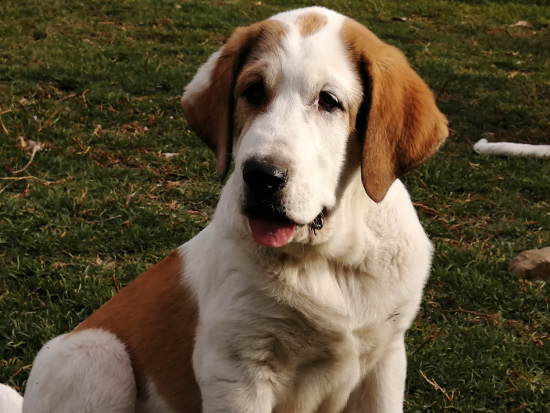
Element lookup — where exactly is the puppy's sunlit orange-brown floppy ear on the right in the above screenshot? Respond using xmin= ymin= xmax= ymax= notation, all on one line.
xmin=341 ymin=19 xmax=449 ymax=202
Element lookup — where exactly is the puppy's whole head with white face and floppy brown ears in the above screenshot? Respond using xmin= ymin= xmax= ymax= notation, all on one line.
xmin=182 ymin=7 xmax=448 ymax=247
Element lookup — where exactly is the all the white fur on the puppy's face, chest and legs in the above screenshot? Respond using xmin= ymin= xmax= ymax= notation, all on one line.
xmin=20 ymin=7 xmax=432 ymax=413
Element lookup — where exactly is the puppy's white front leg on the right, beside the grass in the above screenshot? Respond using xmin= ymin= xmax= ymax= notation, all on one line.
xmin=343 ymin=336 xmax=407 ymax=413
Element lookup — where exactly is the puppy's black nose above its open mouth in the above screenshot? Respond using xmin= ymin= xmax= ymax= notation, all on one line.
xmin=243 ymin=159 xmax=287 ymax=198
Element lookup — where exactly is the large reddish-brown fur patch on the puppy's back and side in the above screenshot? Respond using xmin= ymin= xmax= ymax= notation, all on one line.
xmin=74 ymin=251 xmax=202 ymax=413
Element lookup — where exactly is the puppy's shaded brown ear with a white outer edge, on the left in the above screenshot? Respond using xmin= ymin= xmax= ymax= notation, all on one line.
xmin=181 ymin=21 xmax=284 ymax=179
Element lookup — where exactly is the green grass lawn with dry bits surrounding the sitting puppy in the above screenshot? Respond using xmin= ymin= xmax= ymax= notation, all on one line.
xmin=0 ymin=0 xmax=550 ymax=412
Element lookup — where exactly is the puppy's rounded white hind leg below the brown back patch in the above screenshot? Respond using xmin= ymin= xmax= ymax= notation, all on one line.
xmin=23 ymin=329 xmax=136 ymax=413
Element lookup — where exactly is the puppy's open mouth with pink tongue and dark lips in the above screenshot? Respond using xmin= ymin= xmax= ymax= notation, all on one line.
xmin=246 ymin=208 xmax=326 ymax=248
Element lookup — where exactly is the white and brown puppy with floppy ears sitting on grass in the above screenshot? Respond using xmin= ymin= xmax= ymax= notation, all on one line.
xmin=23 ymin=7 xmax=448 ymax=413
